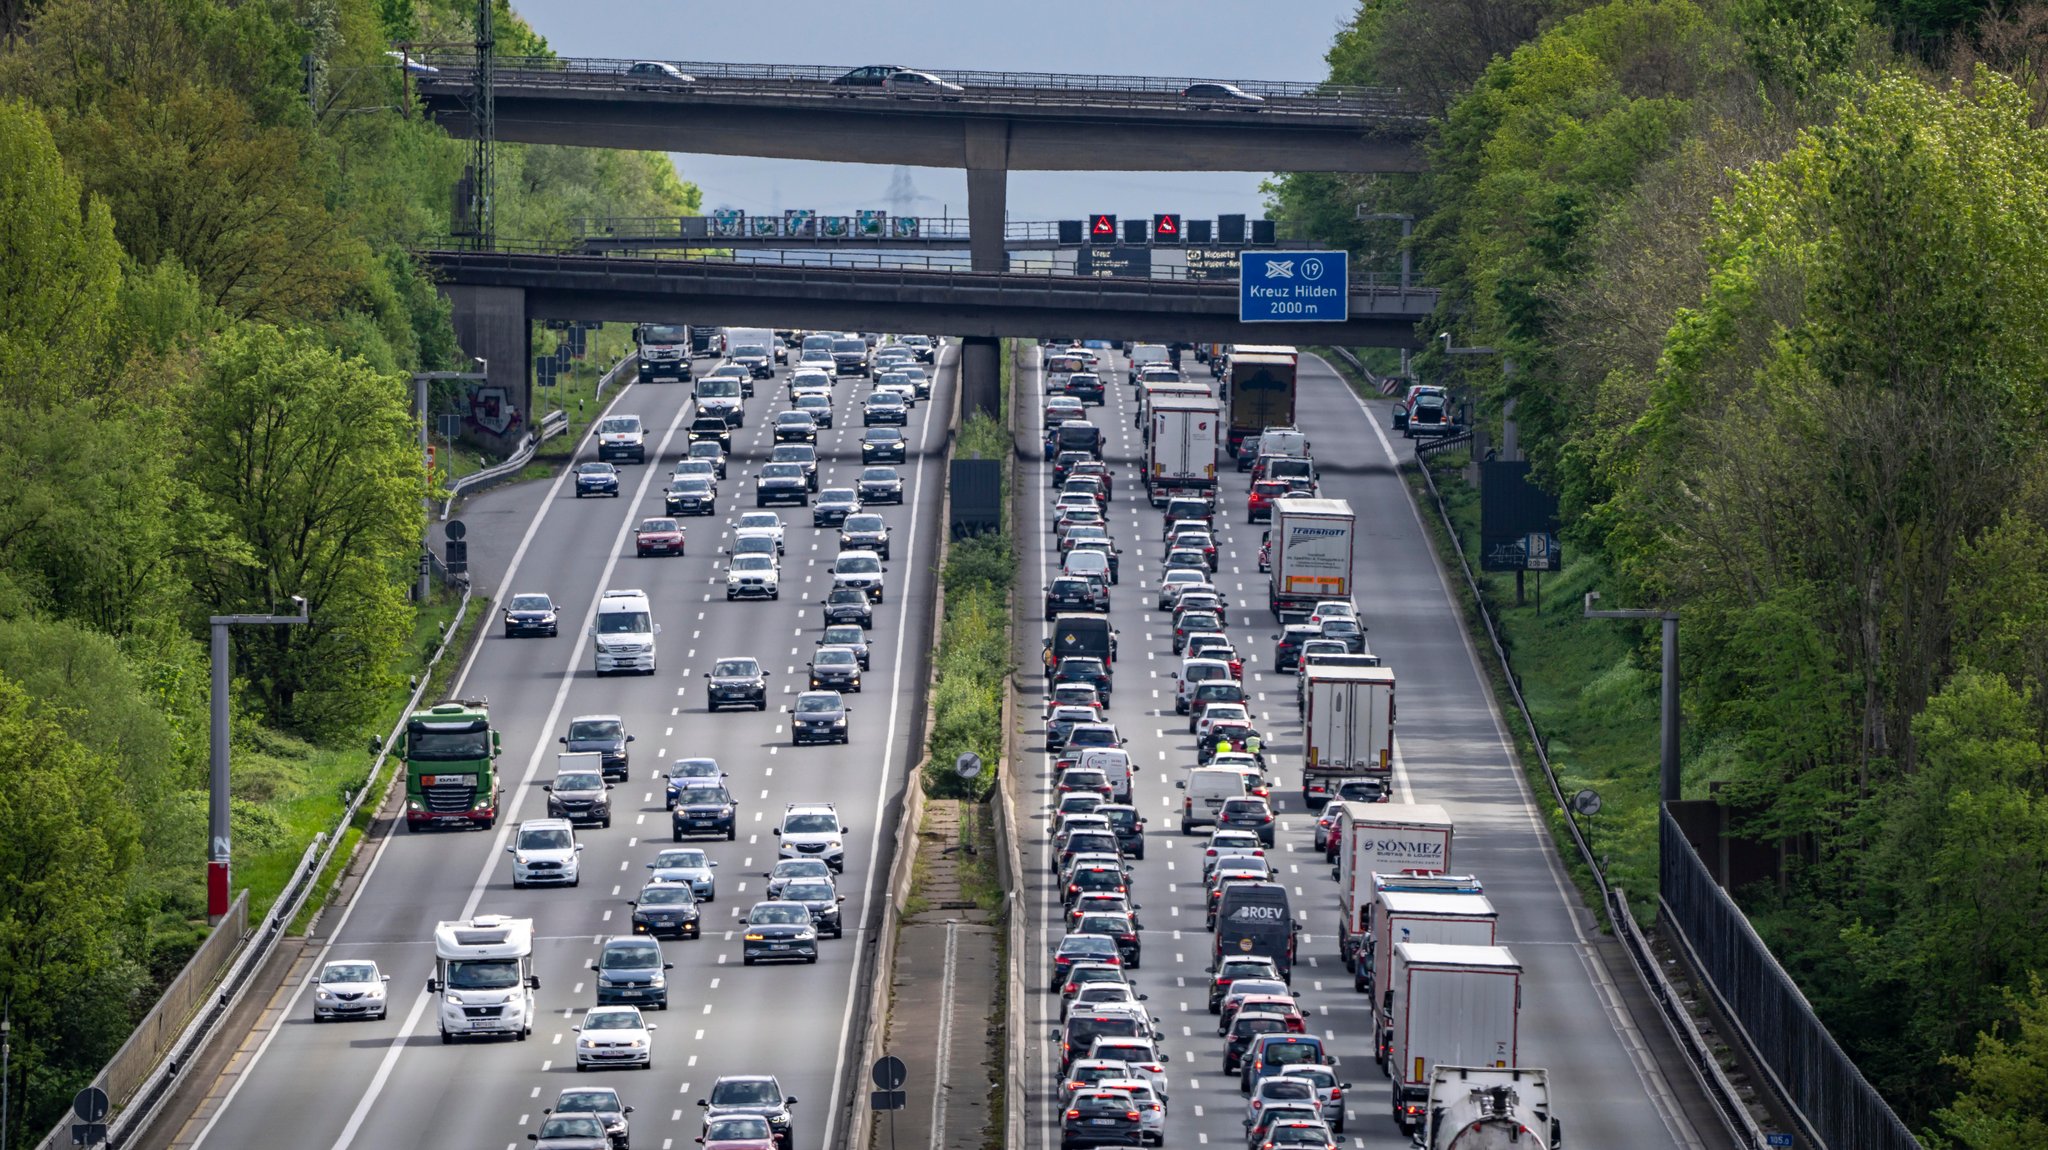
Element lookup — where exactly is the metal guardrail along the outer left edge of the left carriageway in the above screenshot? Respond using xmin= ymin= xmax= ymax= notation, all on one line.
xmin=37 ymin=583 xmax=483 ymax=1150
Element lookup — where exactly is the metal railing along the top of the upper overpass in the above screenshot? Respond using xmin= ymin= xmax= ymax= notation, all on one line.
xmin=410 ymin=53 xmax=1423 ymax=125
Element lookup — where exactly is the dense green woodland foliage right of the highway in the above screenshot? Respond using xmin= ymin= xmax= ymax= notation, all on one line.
xmin=1272 ymin=0 xmax=2048 ymax=1150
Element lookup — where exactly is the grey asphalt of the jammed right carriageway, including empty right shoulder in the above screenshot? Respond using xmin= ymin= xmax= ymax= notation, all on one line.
xmin=1018 ymin=343 xmax=1698 ymax=1150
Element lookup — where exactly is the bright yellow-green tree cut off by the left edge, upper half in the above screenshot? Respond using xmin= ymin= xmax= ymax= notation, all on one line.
xmin=0 ymin=100 xmax=121 ymax=411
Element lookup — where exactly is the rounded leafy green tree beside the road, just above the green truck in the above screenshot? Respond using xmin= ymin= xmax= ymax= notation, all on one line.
xmin=182 ymin=325 xmax=424 ymax=735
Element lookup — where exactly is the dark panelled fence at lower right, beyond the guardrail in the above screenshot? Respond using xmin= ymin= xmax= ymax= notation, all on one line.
xmin=1657 ymin=810 xmax=1919 ymax=1150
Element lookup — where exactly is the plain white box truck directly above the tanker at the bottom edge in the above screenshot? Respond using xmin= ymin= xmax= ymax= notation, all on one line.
xmin=1374 ymin=943 xmax=1522 ymax=1134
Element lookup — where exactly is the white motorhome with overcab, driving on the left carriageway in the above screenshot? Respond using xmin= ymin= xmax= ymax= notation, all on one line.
xmin=426 ymin=915 xmax=541 ymax=1042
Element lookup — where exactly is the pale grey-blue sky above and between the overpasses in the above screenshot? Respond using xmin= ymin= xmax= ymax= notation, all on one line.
xmin=512 ymin=0 xmax=1358 ymax=221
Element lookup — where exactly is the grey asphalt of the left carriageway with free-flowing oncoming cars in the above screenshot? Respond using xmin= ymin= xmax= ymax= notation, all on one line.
xmin=174 ymin=348 xmax=954 ymax=1150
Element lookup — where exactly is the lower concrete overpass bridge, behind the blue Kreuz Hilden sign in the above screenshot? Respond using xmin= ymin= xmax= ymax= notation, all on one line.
xmin=422 ymin=250 xmax=1436 ymax=429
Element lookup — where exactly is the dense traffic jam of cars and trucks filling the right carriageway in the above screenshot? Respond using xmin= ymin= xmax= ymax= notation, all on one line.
xmin=1034 ymin=340 xmax=1561 ymax=1150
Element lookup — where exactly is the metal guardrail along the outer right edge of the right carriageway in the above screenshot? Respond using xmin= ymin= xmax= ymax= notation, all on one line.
xmin=1417 ymin=448 xmax=1777 ymax=1150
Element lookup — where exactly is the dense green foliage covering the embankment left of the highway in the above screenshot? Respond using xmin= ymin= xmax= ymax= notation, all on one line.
xmin=0 ymin=0 xmax=696 ymax=1144
